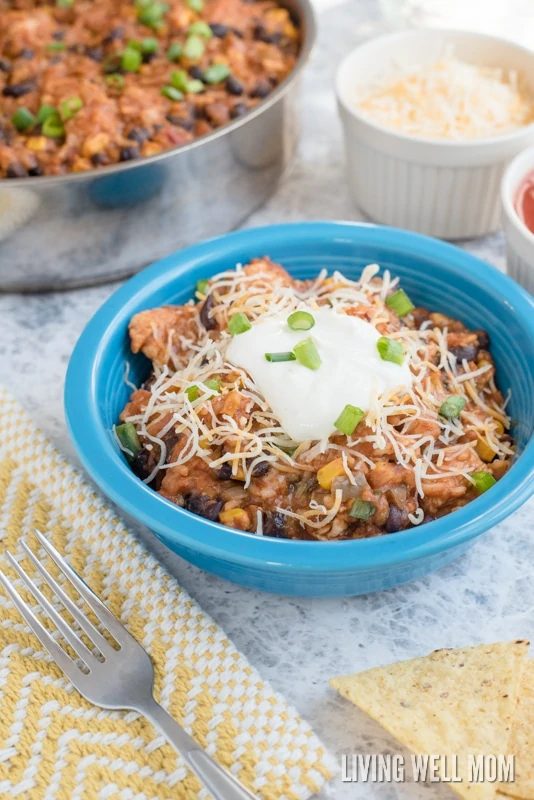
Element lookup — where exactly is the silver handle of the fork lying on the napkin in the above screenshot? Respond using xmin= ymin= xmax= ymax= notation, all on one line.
xmin=136 ymin=698 xmax=258 ymax=800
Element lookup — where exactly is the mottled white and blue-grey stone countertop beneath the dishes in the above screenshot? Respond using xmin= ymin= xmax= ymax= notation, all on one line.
xmin=0 ymin=0 xmax=534 ymax=800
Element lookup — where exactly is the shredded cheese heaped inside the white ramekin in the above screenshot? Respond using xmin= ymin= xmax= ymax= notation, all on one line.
xmin=357 ymin=55 xmax=534 ymax=140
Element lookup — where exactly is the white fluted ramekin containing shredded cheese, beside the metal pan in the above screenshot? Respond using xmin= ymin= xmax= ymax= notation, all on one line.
xmin=336 ymin=30 xmax=534 ymax=239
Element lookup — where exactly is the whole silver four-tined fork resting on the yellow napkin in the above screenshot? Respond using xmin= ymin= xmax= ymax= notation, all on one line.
xmin=0 ymin=530 xmax=256 ymax=800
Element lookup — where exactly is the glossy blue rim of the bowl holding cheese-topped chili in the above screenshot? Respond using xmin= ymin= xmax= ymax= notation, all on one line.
xmin=65 ymin=221 xmax=534 ymax=574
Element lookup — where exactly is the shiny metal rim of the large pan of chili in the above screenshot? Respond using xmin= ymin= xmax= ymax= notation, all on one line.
xmin=0 ymin=0 xmax=317 ymax=188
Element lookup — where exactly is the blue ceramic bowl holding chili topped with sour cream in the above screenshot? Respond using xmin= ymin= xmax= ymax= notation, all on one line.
xmin=65 ymin=222 xmax=534 ymax=597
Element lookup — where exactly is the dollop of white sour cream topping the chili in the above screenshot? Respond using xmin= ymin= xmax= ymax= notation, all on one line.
xmin=227 ymin=308 xmax=413 ymax=442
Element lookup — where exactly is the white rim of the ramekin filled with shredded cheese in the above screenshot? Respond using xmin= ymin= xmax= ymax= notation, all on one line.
xmin=335 ymin=28 xmax=534 ymax=153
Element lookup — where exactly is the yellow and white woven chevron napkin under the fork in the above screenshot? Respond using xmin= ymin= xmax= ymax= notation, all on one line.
xmin=0 ymin=389 xmax=335 ymax=800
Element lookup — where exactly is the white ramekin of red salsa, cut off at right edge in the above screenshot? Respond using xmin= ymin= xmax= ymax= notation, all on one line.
xmin=501 ymin=147 xmax=534 ymax=294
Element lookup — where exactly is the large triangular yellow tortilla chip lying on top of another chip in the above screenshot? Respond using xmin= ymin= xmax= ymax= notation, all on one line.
xmin=330 ymin=641 xmax=529 ymax=800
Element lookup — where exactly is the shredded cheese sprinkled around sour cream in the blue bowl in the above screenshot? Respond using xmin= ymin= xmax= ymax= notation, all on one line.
xmin=118 ymin=264 xmax=514 ymax=538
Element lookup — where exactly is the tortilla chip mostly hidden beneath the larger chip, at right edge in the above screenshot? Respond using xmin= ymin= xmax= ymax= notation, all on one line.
xmin=499 ymin=661 xmax=534 ymax=800
